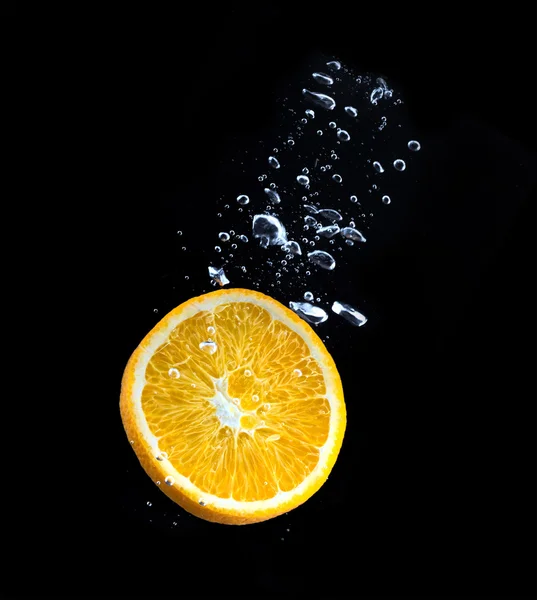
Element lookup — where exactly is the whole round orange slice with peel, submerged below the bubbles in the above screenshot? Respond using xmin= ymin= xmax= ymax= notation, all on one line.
xmin=120 ymin=289 xmax=346 ymax=524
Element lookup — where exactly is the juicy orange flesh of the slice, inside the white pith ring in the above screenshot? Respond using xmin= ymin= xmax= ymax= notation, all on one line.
xmin=142 ymin=302 xmax=330 ymax=502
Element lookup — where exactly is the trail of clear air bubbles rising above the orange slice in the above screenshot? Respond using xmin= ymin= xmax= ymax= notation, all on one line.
xmin=203 ymin=60 xmax=421 ymax=326
